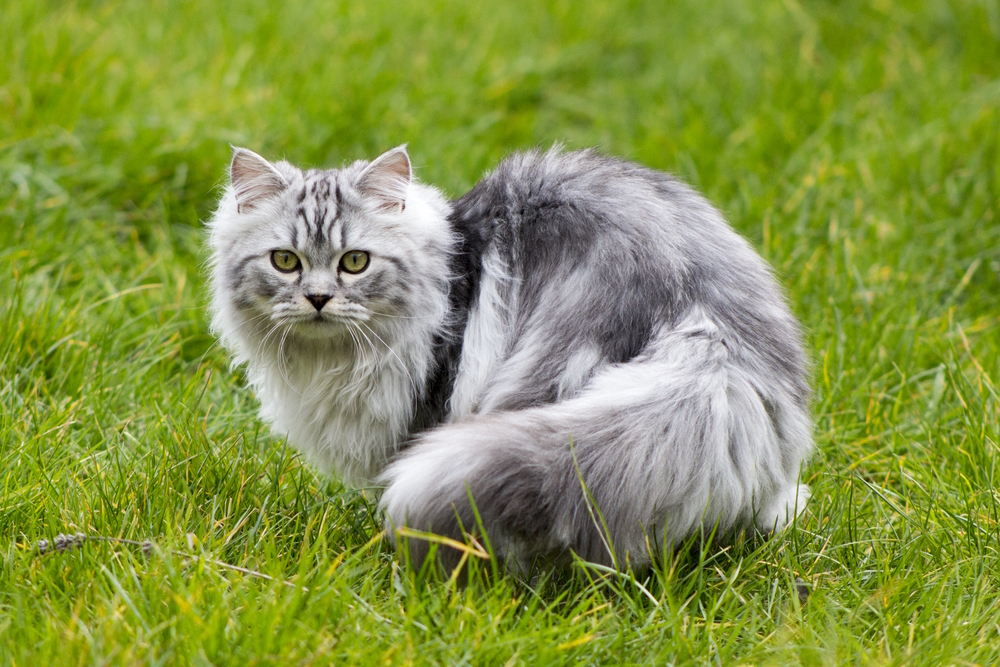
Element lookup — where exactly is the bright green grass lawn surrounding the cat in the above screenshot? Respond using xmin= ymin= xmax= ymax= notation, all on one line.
xmin=0 ymin=0 xmax=1000 ymax=666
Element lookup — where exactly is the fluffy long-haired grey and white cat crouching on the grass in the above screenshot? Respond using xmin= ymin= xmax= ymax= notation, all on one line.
xmin=208 ymin=147 xmax=812 ymax=567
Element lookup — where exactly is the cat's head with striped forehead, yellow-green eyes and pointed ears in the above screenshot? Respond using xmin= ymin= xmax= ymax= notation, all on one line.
xmin=209 ymin=146 xmax=453 ymax=361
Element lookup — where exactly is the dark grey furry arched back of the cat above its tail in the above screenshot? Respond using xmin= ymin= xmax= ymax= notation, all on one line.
xmin=452 ymin=149 xmax=809 ymax=410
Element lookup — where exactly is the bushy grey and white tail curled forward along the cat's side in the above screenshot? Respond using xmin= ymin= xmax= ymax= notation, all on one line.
xmin=381 ymin=310 xmax=812 ymax=567
